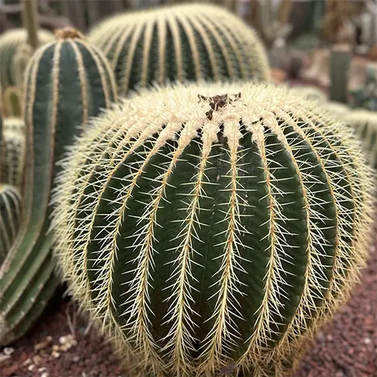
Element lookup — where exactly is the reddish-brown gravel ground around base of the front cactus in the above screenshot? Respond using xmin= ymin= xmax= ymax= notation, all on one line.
xmin=0 ymin=241 xmax=377 ymax=377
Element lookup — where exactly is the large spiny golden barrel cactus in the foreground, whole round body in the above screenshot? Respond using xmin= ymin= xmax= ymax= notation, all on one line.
xmin=53 ymin=84 xmax=373 ymax=376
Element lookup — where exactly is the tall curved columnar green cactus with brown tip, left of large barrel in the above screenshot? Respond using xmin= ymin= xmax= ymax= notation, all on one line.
xmin=0 ymin=29 xmax=116 ymax=345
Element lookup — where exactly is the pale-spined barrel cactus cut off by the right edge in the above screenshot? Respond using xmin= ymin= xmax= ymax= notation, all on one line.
xmin=343 ymin=110 xmax=377 ymax=168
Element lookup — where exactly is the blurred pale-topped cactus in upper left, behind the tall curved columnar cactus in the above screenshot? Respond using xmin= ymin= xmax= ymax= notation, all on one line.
xmin=0 ymin=29 xmax=54 ymax=90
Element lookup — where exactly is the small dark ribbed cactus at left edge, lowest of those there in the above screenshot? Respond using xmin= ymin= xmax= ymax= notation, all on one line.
xmin=0 ymin=184 xmax=21 ymax=264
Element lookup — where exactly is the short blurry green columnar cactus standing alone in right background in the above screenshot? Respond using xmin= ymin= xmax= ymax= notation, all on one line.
xmin=329 ymin=45 xmax=352 ymax=103
